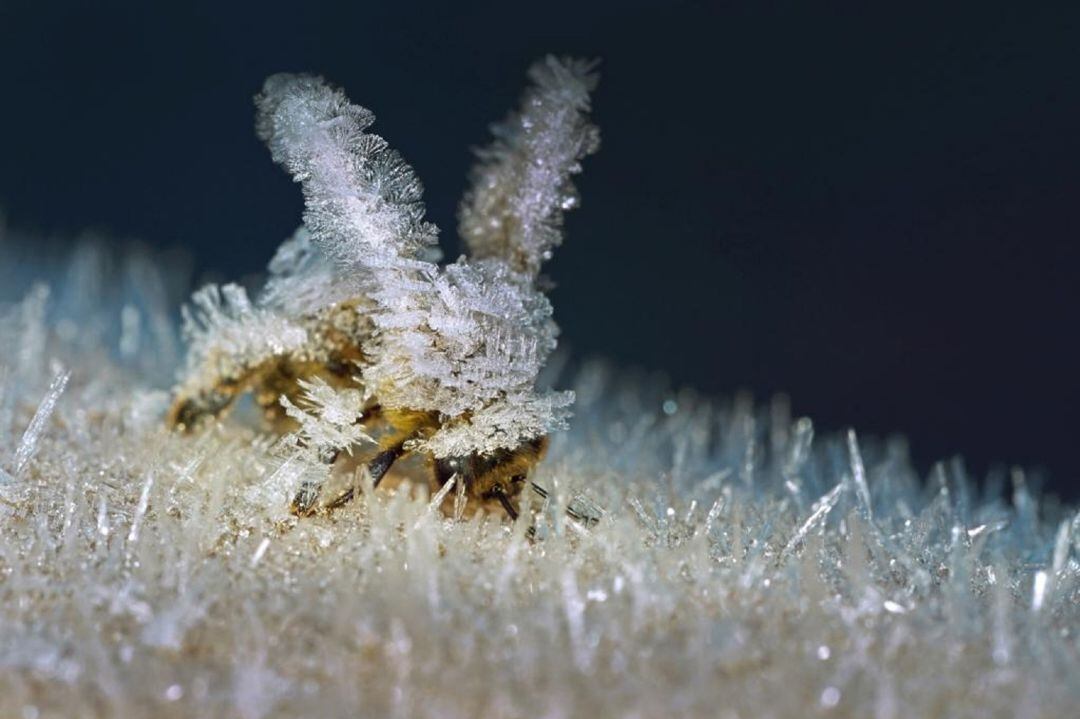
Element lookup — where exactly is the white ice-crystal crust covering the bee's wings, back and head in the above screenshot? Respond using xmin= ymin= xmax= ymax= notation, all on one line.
xmin=183 ymin=57 xmax=598 ymax=457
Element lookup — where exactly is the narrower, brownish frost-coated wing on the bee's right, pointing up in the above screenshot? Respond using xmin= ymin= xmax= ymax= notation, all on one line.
xmin=458 ymin=55 xmax=599 ymax=276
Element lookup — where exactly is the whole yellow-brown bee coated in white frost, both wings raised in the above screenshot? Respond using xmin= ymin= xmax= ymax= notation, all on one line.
xmin=168 ymin=57 xmax=599 ymax=517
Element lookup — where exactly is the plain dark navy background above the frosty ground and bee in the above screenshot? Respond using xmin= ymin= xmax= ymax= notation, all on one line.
xmin=0 ymin=0 xmax=1080 ymax=497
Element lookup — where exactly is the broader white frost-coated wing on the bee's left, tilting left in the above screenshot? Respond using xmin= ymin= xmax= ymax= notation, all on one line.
xmin=255 ymin=74 xmax=437 ymax=270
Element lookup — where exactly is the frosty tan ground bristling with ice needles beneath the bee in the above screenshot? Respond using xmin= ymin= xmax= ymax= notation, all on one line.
xmin=0 ymin=241 xmax=1080 ymax=718
